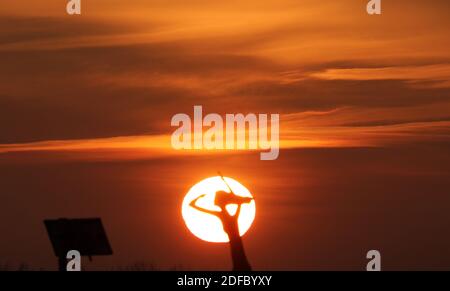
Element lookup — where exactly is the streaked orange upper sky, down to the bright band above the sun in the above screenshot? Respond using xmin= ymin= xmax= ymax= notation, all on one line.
xmin=0 ymin=0 xmax=450 ymax=152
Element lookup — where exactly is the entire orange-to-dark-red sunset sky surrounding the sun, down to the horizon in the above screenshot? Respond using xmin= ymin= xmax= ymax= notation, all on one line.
xmin=0 ymin=0 xmax=450 ymax=269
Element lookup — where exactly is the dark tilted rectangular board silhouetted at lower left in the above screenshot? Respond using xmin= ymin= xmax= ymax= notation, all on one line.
xmin=44 ymin=218 xmax=113 ymax=270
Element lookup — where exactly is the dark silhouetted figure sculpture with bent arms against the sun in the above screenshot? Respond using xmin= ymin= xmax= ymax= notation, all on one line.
xmin=189 ymin=191 xmax=253 ymax=271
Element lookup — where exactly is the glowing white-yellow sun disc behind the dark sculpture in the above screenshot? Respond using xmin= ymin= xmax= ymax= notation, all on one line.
xmin=181 ymin=176 xmax=256 ymax=242
